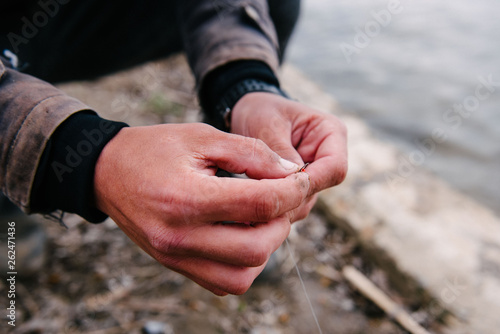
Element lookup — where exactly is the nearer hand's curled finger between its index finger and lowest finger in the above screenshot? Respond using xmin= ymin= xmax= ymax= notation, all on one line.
xmin=158 ymin=217 xmax=291 ymax=267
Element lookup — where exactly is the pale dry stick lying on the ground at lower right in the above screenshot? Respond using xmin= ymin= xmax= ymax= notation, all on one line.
xmin=342 ymin=266 xmax=430 ymax=334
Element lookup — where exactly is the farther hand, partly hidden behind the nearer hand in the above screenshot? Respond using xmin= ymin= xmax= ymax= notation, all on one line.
xmin=231 ymin=92 xmax=347 ymax=221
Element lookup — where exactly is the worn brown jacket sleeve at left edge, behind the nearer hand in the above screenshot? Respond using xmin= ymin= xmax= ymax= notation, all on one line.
xmin=0 ymin=58 xmax=94 ymax=213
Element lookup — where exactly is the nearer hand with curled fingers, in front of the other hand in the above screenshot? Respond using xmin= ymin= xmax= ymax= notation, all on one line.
xmin=94 ymin=124 xmax=310 ymax=295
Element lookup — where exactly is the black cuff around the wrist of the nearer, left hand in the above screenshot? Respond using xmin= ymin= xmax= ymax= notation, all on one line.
xmin=31 ymin=110 xmax=128 ymax=223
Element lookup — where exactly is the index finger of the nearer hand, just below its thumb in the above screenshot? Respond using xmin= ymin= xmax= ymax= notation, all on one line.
xmin=194 ymin=173 xmax=309 ymax=222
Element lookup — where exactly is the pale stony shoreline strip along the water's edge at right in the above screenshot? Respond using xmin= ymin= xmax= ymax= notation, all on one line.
xmin=282 ymin=66 xmax=500 ymax=334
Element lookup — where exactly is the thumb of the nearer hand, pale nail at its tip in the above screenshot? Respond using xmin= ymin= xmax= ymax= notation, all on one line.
xmin=199 ymin=134 xmax=300 ymax=179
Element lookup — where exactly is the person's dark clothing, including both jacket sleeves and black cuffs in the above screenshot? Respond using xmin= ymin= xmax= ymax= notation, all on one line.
xmin=0 ymin=0 xmax=299 ymax=222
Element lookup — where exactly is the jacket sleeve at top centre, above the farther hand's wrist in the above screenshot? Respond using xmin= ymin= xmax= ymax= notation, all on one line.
xmin=178 ymin=0 xmax=279 ymax=88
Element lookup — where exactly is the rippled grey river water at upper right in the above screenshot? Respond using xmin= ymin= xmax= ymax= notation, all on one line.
xmin=287 ymin=0 xmax=500 ymax=215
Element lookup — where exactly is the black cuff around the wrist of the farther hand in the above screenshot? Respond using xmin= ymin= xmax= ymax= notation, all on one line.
xmin=198 ymin=60 xmax=280 ymax=123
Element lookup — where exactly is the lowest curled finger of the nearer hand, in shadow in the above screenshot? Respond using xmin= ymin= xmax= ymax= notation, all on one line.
xmin=164 ymin=257 xmax=267 ymax=296
